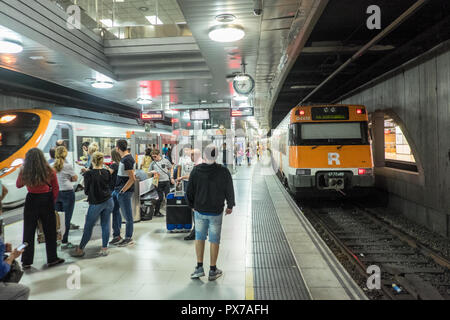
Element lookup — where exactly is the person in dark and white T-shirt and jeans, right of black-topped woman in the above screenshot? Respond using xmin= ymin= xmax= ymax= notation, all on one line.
xmin=110 ymin=140 xmax=136 ymax=247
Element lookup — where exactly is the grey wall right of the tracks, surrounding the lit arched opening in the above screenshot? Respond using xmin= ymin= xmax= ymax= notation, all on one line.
xmin=341 ymin=43 xmax=450 ymax=237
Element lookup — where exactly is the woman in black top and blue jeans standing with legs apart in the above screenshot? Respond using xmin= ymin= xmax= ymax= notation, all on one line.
xmin=71 ymin=152 xmax=114 ymax=257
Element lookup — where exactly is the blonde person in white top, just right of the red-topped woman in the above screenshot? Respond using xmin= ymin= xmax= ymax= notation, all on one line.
xmin=53 ymin=146 xmax=78 ymax=249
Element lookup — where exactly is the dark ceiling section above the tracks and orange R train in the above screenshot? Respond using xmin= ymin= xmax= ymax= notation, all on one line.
xmin=271 ymin=0 xmax=450 ymax=127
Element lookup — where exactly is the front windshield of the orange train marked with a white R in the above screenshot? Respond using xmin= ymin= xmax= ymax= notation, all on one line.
xmin=289 ymin=122 xmax=369 ymax=146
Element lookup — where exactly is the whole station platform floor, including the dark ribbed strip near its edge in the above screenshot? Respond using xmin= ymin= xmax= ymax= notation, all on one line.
xmin=5 ymin=159 xmax=367 ymax=300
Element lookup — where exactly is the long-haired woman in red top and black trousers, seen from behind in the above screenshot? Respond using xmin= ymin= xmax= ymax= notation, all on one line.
xmin=16 ymin=148 xmax=64 ymax=269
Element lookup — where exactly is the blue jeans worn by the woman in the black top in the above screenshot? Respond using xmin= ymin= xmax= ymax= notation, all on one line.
xmin=80 ymin=198 xmax=114 ymax=250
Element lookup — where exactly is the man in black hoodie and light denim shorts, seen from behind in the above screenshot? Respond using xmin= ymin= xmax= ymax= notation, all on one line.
xmin=186 ymin=145 xmax=235 ymax=281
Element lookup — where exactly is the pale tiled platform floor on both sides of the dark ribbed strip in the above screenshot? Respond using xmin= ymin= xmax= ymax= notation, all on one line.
xmin=5 ymin=155 xmax=366 ymax=300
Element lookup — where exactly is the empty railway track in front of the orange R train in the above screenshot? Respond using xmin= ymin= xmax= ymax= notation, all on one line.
xmin=301 ymin=201 xmax=450 ymax=300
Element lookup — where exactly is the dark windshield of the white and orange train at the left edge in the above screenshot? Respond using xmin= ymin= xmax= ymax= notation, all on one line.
xmin=0 ymin=112 xmax=41 ymax=162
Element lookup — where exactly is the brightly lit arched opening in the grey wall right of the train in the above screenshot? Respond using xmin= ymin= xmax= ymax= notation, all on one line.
xmin=384 ymin=117 xmax=417 ymax=172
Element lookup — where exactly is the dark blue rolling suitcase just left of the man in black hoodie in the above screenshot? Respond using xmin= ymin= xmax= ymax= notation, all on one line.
xmin=166 ymin=170 xmax=192 ymax=232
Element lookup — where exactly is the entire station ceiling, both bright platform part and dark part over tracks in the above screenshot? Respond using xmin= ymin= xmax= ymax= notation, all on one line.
xmin=0 ymin=0 xmax=450 ymax=128
